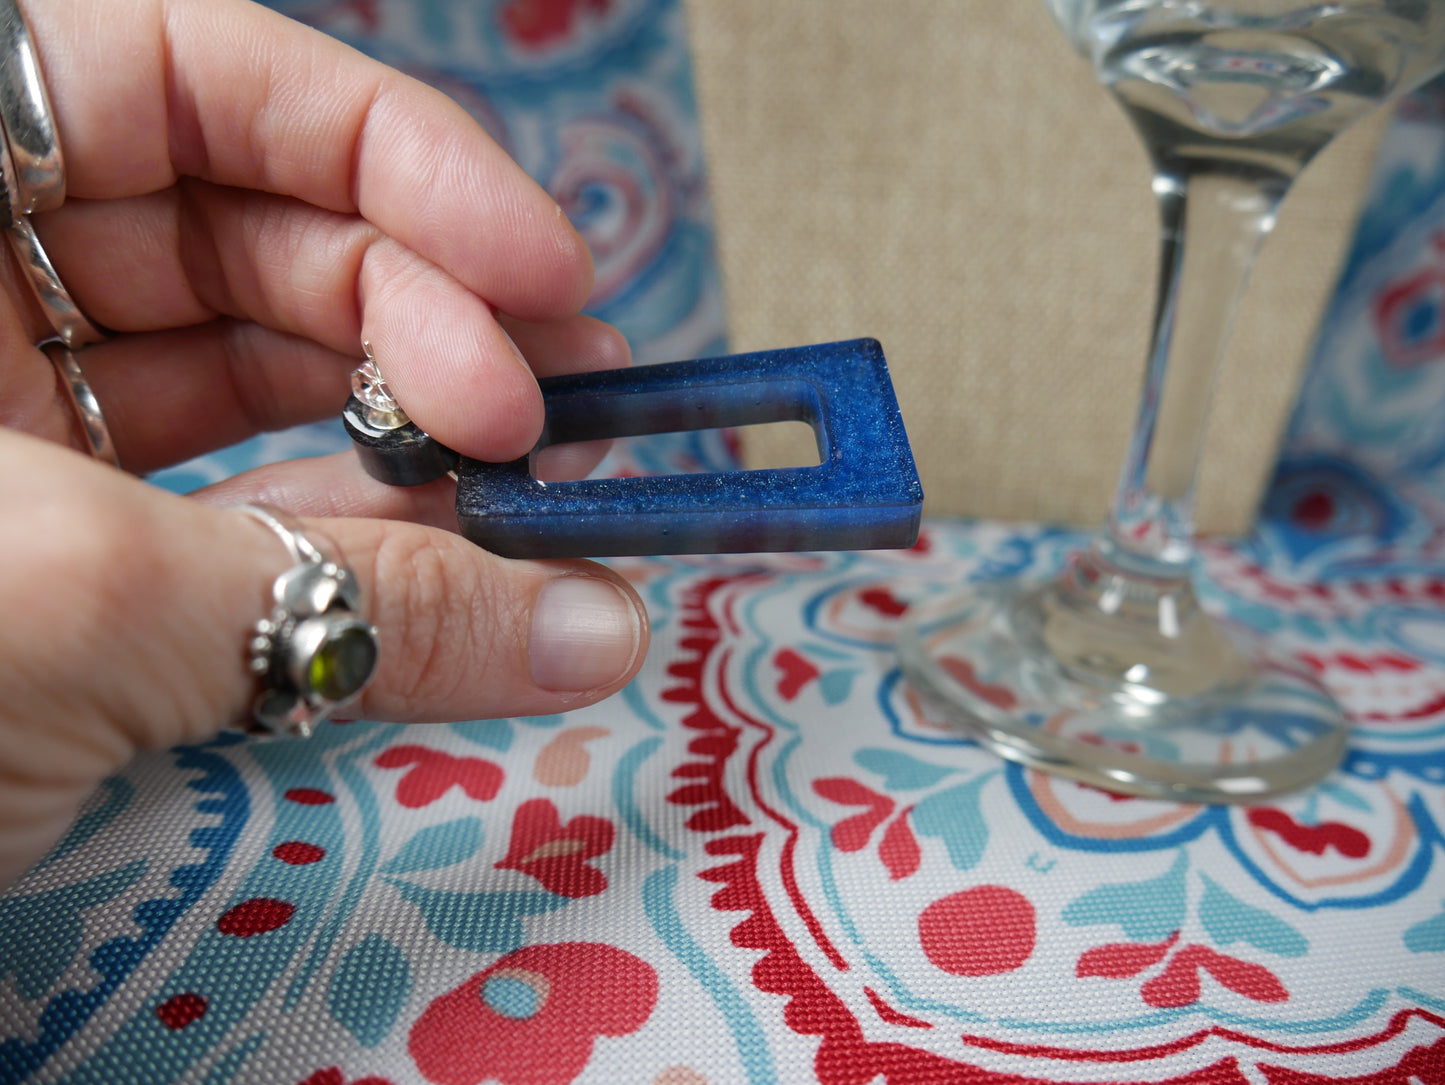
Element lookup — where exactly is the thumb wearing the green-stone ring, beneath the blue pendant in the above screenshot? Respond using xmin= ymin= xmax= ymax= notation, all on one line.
xmin=0 ymin=429 xmax=647 ymax=878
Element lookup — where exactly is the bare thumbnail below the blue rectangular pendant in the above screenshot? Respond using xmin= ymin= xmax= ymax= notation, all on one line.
xmin=529 ymin=576 xmax=642 ymax=691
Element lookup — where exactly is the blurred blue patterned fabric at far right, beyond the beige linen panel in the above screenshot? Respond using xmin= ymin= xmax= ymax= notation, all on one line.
xmin=1266 ymin=78 xmax=1445 ymax=545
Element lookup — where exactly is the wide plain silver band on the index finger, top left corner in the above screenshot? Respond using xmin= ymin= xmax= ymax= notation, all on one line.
xmin=0 ymin=0 xmax=65 ymax=218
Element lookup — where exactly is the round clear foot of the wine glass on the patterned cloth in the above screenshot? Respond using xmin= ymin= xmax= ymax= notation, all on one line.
xmin=899 ymin=582 xmax=1348 ymax=803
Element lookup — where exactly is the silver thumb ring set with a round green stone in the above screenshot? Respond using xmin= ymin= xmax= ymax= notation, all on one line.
xmin=236 ymin=504 xmax=380 ymax=738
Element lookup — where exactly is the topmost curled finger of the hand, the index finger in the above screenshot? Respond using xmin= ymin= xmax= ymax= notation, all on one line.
xmin=23 ymin=0 xmax=591 ymax=321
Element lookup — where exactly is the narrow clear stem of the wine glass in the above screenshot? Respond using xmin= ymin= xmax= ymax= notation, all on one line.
xmin=1097 ymin=163 xmax=1287 ymax=579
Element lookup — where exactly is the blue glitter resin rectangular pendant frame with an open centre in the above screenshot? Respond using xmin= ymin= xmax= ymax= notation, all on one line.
xmin=457 ymin=340 xmax=923 ymax=558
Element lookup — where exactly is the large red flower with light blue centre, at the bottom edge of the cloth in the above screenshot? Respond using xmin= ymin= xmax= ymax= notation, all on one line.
xmin=407 ymin=942 xmax=657 ymax=1085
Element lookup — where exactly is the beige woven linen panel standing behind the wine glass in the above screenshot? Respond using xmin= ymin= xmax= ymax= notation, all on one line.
xmin=686 ymin=0 xmax=1380 ymax=532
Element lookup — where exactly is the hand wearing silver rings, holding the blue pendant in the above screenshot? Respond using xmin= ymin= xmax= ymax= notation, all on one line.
xmin=0 ymin=0 xmax=647 ymax=883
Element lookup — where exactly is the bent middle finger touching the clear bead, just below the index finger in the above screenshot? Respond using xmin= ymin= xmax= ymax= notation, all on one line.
xmin=15 ymin=182 xmax=626 ymax=459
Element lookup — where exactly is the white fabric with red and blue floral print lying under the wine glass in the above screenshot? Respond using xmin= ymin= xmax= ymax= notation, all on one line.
xmin=0 ymin=522 xmax=1445 ymax=1085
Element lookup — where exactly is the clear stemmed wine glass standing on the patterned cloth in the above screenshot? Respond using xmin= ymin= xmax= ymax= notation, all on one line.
xmin=899 ymin=0 xmax=1445 ymax=802
